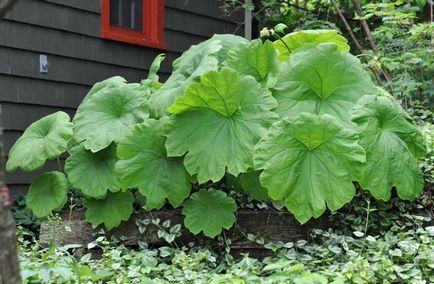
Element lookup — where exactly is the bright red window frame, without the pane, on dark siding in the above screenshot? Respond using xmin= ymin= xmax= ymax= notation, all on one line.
xmin=101 ymin=0 xmax=167 ymax=49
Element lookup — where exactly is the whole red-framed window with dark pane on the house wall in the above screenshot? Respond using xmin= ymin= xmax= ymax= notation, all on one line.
xmin=101 ymin=0 xmax=166 ymax=49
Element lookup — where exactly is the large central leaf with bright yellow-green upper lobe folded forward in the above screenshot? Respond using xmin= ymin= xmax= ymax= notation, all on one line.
xmin=166 ymin=69 xmax=276 ymax=183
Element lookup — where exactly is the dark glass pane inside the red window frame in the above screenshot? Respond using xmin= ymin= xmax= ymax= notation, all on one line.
xmin=110 ymin=0 xmax=143 ymax=32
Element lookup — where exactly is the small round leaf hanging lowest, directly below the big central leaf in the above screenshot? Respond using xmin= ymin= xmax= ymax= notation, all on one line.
xmin=182 ymin=188 xmax=237 ymax=238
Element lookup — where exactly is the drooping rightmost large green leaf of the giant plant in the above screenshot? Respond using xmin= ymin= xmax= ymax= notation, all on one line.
xmin=352 ymin=96 xmax=426 ymax=201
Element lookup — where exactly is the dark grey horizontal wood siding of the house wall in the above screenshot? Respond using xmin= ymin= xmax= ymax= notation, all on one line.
xmin=0 ymin=0 xmax=243 ymax=191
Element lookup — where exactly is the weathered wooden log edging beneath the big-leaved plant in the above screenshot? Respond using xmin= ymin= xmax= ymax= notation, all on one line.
xmin=39 ymin=209 xmax=327 ymax=257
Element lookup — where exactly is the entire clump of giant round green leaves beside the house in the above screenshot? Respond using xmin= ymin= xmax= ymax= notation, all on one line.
xmin=8 ymin=31 xmax=425 ymax=237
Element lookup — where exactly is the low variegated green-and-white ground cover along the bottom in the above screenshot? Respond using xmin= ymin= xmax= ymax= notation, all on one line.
xmin=19 ymin=202 xmax=434 ymax=284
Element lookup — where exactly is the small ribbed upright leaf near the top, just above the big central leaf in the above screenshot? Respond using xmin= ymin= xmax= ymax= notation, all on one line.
xmin=225 ymin=39 xmax=279 ymax=86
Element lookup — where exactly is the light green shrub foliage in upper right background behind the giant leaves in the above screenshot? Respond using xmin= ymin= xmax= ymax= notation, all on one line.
xmin=364 ymin=1 xmax=434 ymax=108
